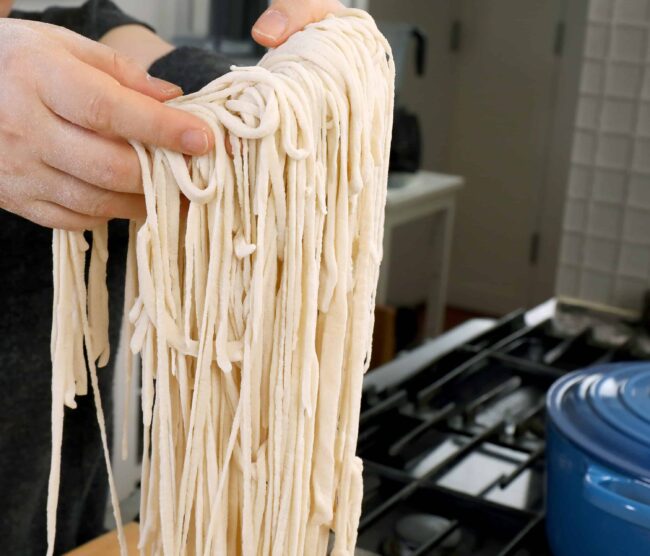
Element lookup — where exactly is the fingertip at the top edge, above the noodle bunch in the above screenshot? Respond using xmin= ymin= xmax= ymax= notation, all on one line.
xmin=252 ymin=0 xmax=344 ymax=48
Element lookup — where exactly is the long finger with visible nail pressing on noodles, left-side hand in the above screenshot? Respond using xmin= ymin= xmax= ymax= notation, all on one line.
xmin=37 ymin=53 xmax=214 ymax=155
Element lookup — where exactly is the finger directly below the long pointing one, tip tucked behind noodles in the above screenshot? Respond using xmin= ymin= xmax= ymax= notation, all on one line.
xmin=39 ymin=116 xmax=142 ymax=193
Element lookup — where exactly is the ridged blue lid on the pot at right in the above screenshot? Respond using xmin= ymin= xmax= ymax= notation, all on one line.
xmin=547 ymin=362 xmax=650 ymax=479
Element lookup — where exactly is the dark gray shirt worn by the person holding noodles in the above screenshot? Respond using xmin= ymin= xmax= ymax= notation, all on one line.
xmin=0 ymin=0 xmax=229 ymax=556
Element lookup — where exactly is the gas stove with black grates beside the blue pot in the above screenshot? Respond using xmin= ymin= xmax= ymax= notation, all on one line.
xmin=357 ymin=301 xmax=650 ymax=556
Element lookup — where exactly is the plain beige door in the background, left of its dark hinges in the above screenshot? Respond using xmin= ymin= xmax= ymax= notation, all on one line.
xmin=448 ymin=0 xmax=566 ymax=314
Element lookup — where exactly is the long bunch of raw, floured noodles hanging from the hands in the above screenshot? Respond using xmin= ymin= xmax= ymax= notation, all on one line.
xmin=48 ymin=10 xmax=394 ymax=556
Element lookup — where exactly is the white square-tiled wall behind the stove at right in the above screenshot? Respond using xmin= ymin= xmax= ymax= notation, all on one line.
xmin=556 ymin=0 xmax=650 ymax=309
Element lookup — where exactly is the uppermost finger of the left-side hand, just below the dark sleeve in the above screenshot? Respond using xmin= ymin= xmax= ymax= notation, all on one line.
xmin=48 ymin=23 xmax=183 ymax=101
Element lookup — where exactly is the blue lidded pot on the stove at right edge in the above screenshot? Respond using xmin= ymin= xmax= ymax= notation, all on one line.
xmin=546 ymin=363 xmax=650 ymax=556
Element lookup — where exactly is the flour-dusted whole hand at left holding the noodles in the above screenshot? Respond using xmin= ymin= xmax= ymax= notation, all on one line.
xmin=0 ymin=19 xmax=214 ymax=230
